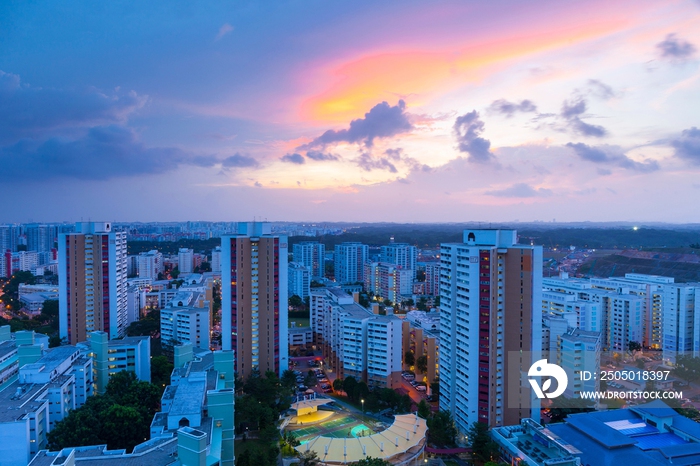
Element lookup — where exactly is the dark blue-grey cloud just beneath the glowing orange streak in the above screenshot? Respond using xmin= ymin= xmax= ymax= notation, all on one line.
xmin=299 ymin=100 xmax=413 ymax=150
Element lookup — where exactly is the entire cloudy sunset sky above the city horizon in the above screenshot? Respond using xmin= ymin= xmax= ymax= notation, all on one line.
xmin=0 ymin=0 xmax=700 ymax=223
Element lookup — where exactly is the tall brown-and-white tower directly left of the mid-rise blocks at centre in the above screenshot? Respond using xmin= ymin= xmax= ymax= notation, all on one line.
xmin=221 ymin=222 xmax=288 ymax=377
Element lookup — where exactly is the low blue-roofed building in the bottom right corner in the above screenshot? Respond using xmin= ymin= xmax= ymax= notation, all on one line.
xmin=491 ymin=400 xmax=700 ymax=466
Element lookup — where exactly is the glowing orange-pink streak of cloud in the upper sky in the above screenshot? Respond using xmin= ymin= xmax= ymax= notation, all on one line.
xmin=300 ymin=17 xmax=628 ymax=122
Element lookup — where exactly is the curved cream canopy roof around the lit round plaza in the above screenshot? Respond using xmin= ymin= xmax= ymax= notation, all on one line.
xmin=296 ymin=414 xmax=428 ymax=465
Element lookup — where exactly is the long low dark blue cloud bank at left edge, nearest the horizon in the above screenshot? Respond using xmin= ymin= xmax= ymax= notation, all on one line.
xmin=0 ymin=125 xmax=221 ymax=181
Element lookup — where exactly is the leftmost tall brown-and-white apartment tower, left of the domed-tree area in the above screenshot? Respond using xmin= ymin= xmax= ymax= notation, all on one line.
xmin=58 ymin=222 xmax=127 ymax=345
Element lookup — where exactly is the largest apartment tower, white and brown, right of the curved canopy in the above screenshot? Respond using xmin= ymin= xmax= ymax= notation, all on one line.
xmin=439 ymin=230 xmax=542 ymax=432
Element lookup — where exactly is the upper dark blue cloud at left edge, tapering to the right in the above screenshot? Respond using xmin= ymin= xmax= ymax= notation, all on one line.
xmin=0 ymin=71 xmax=147 ymax=144
